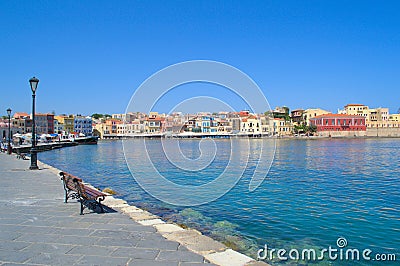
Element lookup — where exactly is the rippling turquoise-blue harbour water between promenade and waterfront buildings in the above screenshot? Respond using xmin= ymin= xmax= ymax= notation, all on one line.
xmin=39 ymin=139 xmax=400 ymax=265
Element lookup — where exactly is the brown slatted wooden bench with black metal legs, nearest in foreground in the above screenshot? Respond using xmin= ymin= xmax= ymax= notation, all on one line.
xmin=60 ymin=172 xmax=107 ymax=215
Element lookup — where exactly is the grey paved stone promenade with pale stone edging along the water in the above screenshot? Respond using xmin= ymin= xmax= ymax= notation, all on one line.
xmin=0 ymin=153 xmax=266 ymax=266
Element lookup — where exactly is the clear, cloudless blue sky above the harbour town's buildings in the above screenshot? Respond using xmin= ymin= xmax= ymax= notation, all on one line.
xmin=0 ymin=0 xmax=400 ymax=114
